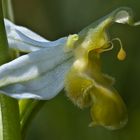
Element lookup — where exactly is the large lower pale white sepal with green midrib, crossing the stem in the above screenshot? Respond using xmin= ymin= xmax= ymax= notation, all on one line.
xmin=0 ymin=41 xmax=72 ymax=100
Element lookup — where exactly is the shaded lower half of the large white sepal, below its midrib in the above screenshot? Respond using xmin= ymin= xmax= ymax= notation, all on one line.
xmin=0 ymin=59 xmax=72 ymax=100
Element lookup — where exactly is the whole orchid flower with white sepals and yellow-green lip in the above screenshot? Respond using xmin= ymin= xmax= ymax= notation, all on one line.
xmin=0 ymin=8 xmax=138 ymax=129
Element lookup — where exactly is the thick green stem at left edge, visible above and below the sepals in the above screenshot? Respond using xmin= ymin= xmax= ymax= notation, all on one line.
xmin=0 ymin=0 xmax=21 ymax=140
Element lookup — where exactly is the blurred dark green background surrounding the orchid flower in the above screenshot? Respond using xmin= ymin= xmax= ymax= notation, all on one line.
xmin=13 ymin=0 xmax=140 ymax=140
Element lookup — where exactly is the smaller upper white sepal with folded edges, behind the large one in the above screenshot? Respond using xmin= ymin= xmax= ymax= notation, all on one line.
xmin=4 ymin=19 xmax=67 ymax=52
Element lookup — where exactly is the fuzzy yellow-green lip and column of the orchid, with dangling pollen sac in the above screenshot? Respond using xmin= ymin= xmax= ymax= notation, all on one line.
xmin=65 ymin=8 xmax=131 ymax=130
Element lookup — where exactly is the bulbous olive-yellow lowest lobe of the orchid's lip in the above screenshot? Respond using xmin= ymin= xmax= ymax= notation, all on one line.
xmin=90 ymin=85 xmax=128 ymax=130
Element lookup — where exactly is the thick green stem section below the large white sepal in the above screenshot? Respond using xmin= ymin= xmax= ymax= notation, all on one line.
xmin=0 ymin=95 xmax=21 ymax=140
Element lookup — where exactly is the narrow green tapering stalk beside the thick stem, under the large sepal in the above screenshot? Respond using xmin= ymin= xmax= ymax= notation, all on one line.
xmin=19 ymin=99 xmax=46 ymax=139
